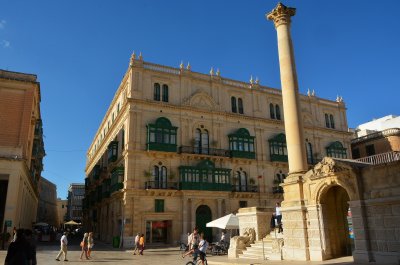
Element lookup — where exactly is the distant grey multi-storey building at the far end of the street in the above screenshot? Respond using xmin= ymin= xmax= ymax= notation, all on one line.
xmin=67 ymin=183 xmax=85 ymax=223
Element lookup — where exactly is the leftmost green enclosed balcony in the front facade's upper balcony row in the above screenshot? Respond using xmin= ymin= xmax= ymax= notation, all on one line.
xmin=147 ymin=117 xmax=178 ymax=152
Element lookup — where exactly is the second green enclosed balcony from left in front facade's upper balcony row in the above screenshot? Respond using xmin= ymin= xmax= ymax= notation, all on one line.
xmin=228 ymin=128 xmax=255 ymax=159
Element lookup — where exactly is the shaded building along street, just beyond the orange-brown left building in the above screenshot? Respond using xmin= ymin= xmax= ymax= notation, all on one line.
xmin=36 ymin=177 xmax=59 ymax=227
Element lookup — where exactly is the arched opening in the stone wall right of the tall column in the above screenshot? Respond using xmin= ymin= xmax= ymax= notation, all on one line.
xmin=320 ymin=186 xmax=351 ymax=259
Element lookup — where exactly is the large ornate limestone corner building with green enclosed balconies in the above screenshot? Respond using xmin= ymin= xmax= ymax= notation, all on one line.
xmin=84 ymin=55 xmax=351 ymax=243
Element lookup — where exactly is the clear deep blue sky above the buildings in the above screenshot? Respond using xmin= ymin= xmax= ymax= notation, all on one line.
xmin=0 ymin=0 xmax=400 ymax=198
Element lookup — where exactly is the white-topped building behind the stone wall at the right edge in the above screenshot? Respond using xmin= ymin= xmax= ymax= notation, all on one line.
xmin=351 ymin=115 xmax=400 ymax=159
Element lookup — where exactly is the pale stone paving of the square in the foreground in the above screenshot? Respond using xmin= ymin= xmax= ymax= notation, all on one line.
xmin=0 ymin=239 xmax=368 ymax=265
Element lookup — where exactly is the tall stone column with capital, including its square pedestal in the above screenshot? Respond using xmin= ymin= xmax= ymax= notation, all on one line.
xmin=266 ymin=3 xmax=310 ymax=260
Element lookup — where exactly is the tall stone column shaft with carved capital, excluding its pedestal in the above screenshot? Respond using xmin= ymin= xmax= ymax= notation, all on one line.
xmin=266 ymin=3 xmax=307 ymax=174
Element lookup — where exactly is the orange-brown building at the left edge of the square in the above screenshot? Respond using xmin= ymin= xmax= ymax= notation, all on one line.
xmin=0 ymin=70 xmax=45 ymax=232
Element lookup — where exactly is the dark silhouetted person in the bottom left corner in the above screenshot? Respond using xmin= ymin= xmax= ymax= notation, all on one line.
xmin=4 ymin=229 xmax=32 ymax=265
